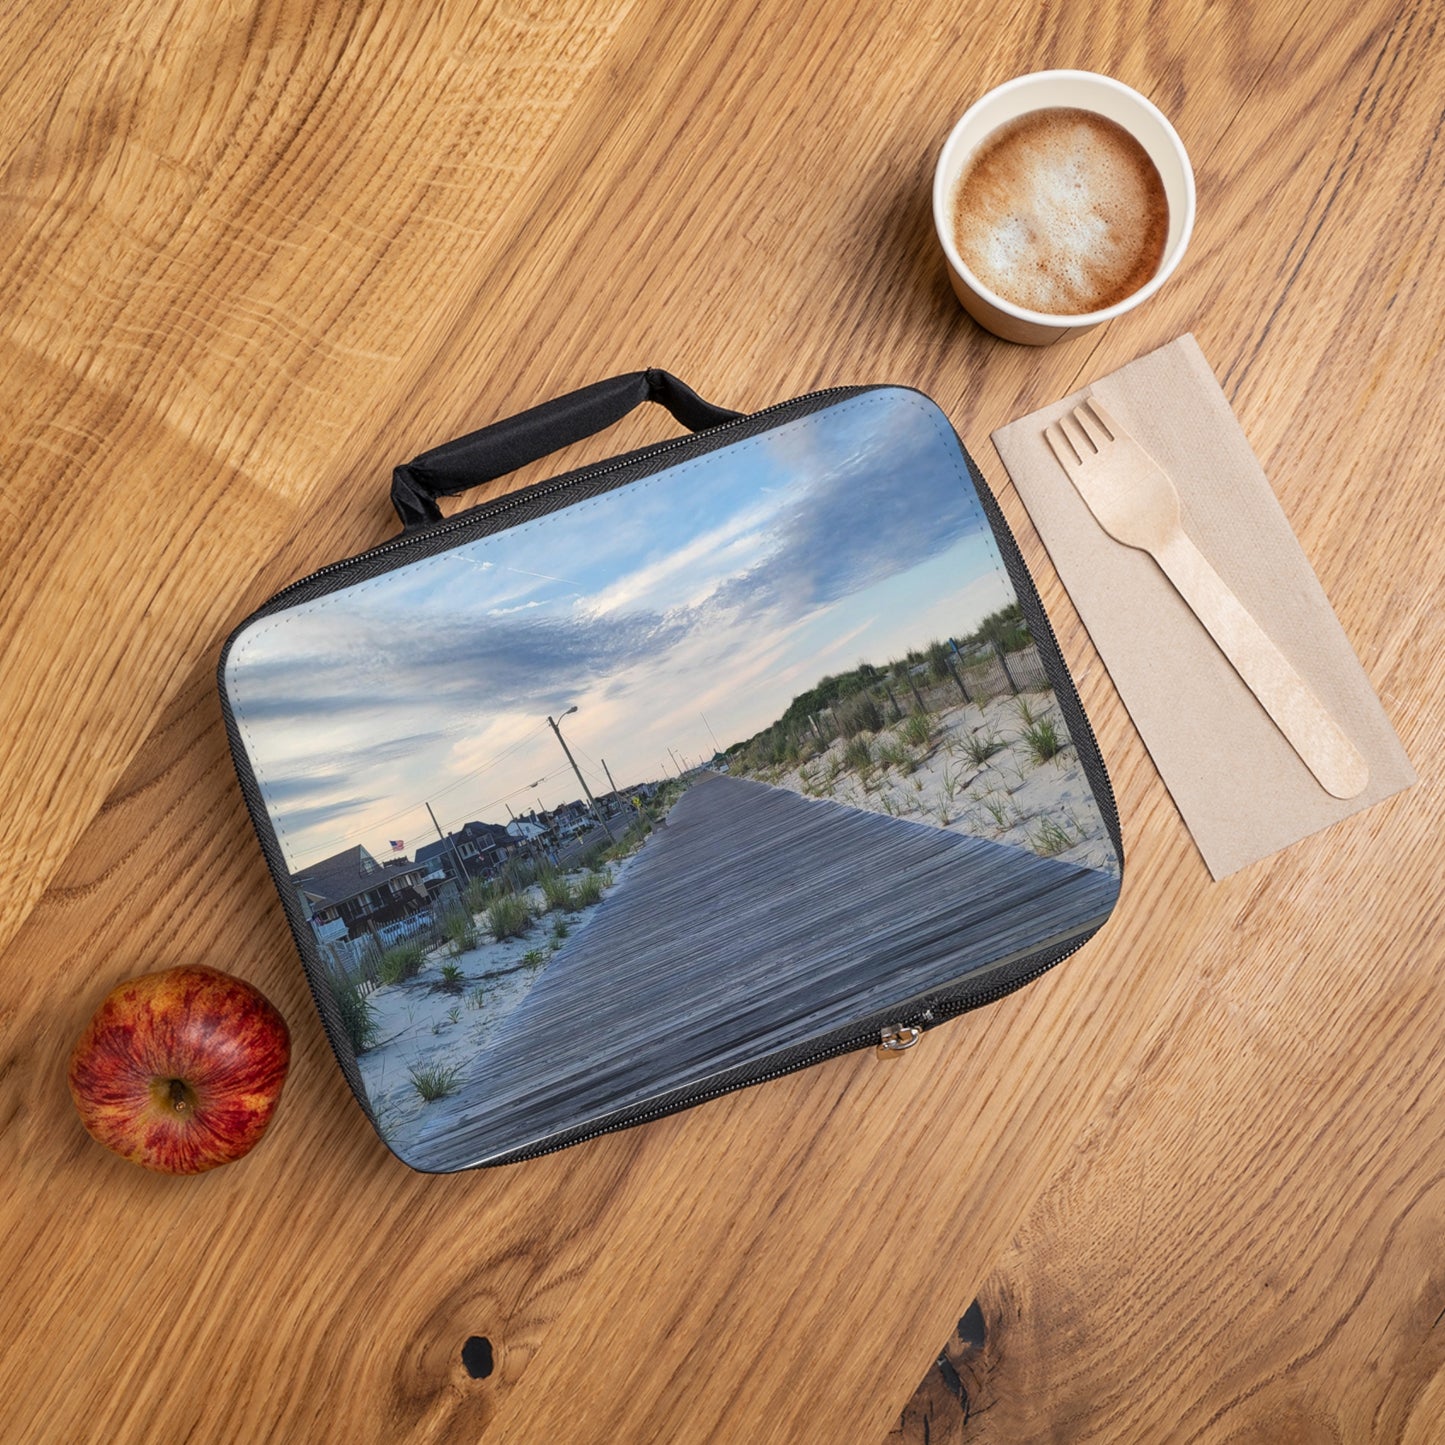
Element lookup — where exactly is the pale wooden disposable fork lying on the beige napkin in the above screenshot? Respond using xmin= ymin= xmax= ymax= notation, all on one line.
xmin=1043 ymin=399 xmax=1370 ymax=798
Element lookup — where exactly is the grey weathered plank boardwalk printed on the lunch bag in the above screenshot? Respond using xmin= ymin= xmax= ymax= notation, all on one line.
xmin=416 ymin=776 xmax=1118 ymax=1169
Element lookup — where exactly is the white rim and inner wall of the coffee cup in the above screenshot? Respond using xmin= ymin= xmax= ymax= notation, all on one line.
xmin=933 ymin=69 xmax=1195 ymax=331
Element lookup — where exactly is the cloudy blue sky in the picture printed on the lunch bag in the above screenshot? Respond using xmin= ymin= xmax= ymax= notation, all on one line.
xmin=227 ymin=392 xmax=1013 ymax=870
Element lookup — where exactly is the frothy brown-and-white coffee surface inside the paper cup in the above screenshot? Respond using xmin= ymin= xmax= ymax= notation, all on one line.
xmin=954 ymin=107 xmax=1169 ymax=316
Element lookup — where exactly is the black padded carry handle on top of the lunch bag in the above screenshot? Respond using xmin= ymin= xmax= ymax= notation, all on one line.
xmin=392 ymin=367 xmax=743 ymax=529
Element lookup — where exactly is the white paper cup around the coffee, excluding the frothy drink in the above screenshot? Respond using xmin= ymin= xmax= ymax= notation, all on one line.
xmin=933 ymin=71 xmax=1195 ymax=345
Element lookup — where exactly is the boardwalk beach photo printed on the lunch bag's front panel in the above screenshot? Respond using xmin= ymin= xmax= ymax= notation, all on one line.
xmin=225 ymin=390 xmax=1118 ymax=1170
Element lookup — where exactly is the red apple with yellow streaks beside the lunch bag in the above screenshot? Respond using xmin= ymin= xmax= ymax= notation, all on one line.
xmin=69 ymin=964 xmax=290 ymax=1173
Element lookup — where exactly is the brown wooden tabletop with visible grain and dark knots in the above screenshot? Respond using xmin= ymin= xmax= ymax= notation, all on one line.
xmin=0 ymin=0 xmax=1445 ymax=1445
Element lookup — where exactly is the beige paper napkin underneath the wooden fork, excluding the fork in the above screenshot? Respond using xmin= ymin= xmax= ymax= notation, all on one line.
xmin=994 ymin=335 xmax=1415 ymax=879
